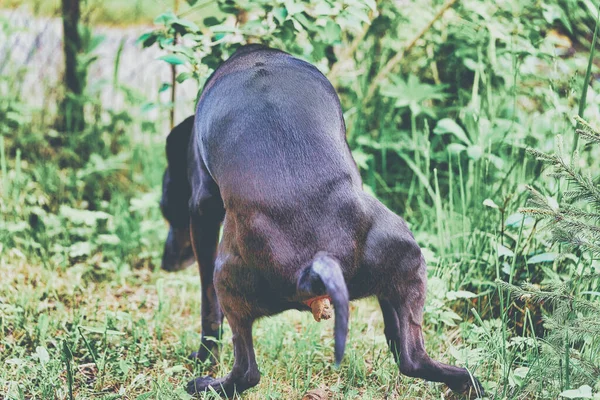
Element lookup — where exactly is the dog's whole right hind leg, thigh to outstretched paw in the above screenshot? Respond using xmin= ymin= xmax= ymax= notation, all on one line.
xmin=364 ymin=199 xmax=483 ymax=394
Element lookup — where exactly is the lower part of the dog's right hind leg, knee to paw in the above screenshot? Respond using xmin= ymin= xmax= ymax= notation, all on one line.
xmin=379 ymin=265 xmax=481 ymax=392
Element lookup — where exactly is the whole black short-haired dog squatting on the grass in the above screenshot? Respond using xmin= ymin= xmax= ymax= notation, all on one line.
xmin=161 ymin=45 xmax=481 ymax=396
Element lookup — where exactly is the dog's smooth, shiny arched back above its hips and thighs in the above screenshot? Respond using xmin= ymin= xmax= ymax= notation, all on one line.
xmin=195 ymin=46 xmax=360 ymax=208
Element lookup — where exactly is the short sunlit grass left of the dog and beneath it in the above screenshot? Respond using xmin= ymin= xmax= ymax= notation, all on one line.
xmin=0 ymin=257 xmax=482 ymax=399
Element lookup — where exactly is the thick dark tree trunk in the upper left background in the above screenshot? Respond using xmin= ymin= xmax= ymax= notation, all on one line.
xmin=58 ymin=0 xmax=85 ymax=131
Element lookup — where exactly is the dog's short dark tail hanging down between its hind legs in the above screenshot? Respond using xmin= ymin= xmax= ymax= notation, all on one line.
xmin=298 ymin=253 xmax=350 ymax=366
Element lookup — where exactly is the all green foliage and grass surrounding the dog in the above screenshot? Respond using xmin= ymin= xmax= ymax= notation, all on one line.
xmin=0 ymin=0 xmax=600 ymax=399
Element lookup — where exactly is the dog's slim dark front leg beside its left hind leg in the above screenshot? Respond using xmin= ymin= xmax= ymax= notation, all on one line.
xmin=190 ymin=161 xmax=225 ymax=363
